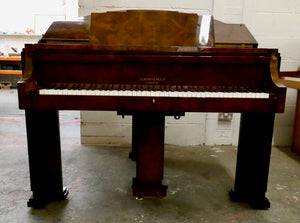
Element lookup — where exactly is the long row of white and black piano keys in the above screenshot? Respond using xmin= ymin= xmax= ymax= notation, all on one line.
xmin=39 ymin=84 xmax=269 ymax=99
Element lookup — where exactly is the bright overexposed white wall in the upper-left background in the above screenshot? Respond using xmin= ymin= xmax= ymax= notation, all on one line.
xmin=0 ymin=0 xmax=78 ymax=35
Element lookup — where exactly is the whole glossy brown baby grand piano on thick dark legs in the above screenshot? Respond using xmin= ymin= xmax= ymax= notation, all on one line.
xmin=18 ymin=10 xmax=286 ymax=209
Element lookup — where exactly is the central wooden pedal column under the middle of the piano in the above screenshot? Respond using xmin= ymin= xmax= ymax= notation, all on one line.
xmin=132 ymin=112 xmax=167 ymax=198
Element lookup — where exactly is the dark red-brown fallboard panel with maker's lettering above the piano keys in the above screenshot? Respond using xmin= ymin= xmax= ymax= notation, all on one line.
xmin=25 ymin=45 xmax=277 ymax=91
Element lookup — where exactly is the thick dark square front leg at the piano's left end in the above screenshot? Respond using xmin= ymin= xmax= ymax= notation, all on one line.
xmin=25 ymin=110 xmax=69 ymax=208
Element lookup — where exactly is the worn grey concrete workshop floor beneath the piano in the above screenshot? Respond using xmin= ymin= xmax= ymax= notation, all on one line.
xmin=0 ymin=90 xmax=300 ymax=223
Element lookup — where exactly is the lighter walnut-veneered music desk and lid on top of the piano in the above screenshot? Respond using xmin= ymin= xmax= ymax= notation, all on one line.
xmin=40 ymin=10 xmax=257 ymax=48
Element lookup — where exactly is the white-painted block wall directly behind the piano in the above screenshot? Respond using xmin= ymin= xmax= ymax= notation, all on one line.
xmin=78 ymin=0 xmax=300 ymax=145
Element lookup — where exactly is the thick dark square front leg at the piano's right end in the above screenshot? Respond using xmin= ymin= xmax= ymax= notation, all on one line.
xmin=229 ymin=113 xmax=275 ymax=209
